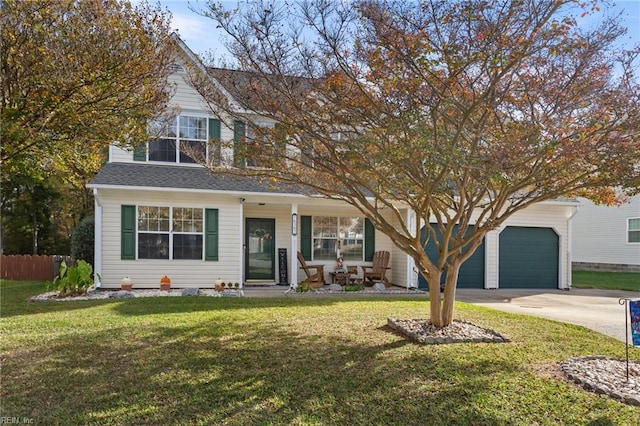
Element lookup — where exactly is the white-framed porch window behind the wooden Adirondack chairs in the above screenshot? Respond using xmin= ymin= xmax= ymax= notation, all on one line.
xmin=312 ymin=216 xmax=364 ymax=261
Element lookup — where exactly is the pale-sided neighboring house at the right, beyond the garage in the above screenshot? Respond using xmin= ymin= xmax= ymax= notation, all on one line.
xmin=571 ymin=195 xmax=640 ymax=272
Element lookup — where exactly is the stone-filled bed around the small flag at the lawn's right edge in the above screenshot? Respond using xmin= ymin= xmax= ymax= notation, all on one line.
xmin=560 ymin=356 xmax=640 ymax=406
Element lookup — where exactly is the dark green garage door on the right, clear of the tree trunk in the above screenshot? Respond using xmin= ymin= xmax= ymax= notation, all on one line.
xmin=499 ymin=226 xmax=560 ymax=288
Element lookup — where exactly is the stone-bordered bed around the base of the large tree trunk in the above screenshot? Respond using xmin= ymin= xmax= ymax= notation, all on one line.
xmin=387 ymin=318 xmax=510 ymax=344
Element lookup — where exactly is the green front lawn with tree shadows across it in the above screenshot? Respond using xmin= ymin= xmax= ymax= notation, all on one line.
xmin=0 ymin=281 xmax=640 ymax=425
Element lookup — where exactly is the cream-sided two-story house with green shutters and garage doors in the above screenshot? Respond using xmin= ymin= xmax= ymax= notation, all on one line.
xmin=88 ymin=38 xmax=576 ymax=288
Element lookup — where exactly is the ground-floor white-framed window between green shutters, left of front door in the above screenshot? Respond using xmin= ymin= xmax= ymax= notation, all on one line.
xmin=137 ymin=206 xmax=204 ymax=260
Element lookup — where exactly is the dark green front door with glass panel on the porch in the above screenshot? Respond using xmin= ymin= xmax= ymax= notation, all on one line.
xmin=244 ymin=218 xmax=276 ymax=281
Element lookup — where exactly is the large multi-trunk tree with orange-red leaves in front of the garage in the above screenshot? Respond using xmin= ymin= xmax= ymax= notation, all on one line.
xmin=193 ymin=0 xmax=640 ymax=326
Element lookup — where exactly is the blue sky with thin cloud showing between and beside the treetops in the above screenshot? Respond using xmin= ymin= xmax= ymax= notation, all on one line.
xmin=156 ymin=0 xmax=640 ymax=56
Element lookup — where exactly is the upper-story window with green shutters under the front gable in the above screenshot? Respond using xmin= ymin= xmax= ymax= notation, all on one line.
xmin=134 ymin=115 xmax=220 ymax=164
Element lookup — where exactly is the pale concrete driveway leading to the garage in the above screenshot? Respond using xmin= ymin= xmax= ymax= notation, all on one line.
xmin=456 ymin=288 xmax=640 ymax=342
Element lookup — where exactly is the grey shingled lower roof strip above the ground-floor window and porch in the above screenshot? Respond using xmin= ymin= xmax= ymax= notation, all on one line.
xmin=87 ymin=163 xmax=305 ymax=194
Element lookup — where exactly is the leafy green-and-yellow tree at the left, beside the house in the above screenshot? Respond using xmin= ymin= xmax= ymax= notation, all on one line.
xmin=0 ymin=0 xmax=173 ymax=253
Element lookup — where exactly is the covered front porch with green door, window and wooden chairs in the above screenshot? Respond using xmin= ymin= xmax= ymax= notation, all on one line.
xmin=240 ymin=194 xmax=416 ymax=288
